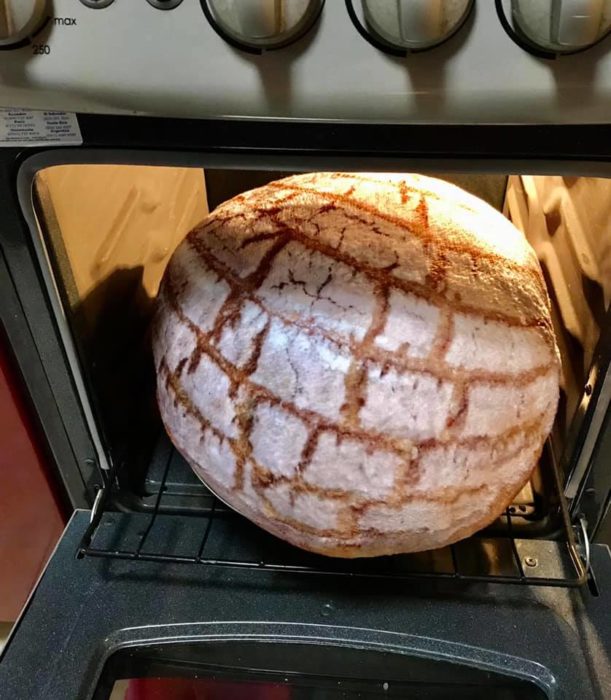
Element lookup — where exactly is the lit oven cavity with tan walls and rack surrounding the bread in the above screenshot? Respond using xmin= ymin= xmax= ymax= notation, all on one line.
xmin=28 ymin=164 xmax=611 ymax=592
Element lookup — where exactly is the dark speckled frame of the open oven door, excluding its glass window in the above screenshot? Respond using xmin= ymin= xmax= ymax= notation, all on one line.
xmin=0 ymin=511 xmax=611 ymax=700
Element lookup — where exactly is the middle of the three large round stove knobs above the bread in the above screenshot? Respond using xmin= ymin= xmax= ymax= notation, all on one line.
xmin=363 ymin=0 xmax=473 ymax=51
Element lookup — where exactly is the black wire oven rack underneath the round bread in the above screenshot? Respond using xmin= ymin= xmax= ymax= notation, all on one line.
xmin=78 ymin=436 xmax=588 ymax=587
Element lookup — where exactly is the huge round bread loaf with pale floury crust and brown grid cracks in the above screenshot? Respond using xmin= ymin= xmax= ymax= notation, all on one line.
xmin=153 ymin=173 xmax=559 ymax=557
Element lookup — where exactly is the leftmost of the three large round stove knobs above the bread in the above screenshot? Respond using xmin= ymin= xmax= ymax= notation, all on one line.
xmin=204 ymin=0 xmax=324 ymax=51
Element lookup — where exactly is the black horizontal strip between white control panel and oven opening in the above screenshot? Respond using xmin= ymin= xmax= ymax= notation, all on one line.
xmin=73 ymin=115 xmax=611 ymax=161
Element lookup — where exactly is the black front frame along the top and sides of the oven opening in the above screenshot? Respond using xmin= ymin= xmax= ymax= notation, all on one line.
xmin=0 ymin=115 xmax=611 ymax=536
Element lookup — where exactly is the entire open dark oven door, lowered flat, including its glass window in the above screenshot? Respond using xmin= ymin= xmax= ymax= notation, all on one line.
xmin=0 ymin=511 xmax=611 ymax=700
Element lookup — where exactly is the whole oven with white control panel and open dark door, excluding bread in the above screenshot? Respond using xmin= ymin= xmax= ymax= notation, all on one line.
xmin=0 ymin=0 xmax=611 ymax=700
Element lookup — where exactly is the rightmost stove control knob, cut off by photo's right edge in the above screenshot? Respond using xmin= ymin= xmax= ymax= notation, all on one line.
xmin=511 ymin=0 xmax=611 ymax=53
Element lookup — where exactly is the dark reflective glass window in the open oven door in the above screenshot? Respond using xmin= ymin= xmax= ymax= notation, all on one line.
xmin=95 ymin=641 xmax=548 ymax=700
